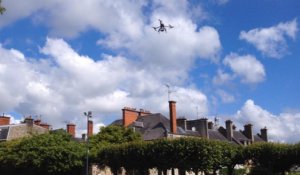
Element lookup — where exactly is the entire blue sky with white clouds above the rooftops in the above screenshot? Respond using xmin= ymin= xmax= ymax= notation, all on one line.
xmin=0 ymin=0 xmax=300 ymax=143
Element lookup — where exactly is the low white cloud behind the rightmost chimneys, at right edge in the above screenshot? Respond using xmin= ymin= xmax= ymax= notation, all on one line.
xmin=235 ymin=99 xmax=300 ymax=143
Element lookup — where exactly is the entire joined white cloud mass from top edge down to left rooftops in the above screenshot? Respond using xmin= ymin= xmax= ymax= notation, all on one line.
xmin=0 ymin=0 xmax=218 ymax=135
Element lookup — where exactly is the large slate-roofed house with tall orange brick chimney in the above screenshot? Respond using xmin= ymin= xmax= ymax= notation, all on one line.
xmin=111 ymin=101 xmax=268 ymax=145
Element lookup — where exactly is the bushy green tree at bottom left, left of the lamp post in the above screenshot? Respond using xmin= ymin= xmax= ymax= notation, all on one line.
xmin=0 ymin=131 xmax=84 ymax=175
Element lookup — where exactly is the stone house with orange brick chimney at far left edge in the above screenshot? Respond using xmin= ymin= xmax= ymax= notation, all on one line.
xmin=0 ymin=115 xmax=50 ymax=141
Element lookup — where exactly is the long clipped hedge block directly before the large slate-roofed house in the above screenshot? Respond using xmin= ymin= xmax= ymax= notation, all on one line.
xmin=98 ymin=138 xmax=240 ymax=172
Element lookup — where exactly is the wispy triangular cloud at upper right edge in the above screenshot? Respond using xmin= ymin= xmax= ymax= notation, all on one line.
xmin=240 ymin=19 xmax=298 ymax=58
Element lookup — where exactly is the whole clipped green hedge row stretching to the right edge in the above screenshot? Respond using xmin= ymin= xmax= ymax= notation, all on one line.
xmin=96 ymin=138 xmax=300 ymax=174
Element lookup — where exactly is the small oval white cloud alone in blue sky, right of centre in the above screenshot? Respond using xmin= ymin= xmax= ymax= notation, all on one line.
xmin=223 ymin=53 xmax=266 ymax=84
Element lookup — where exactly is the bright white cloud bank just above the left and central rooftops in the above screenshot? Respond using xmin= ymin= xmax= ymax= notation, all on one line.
xmin=0 ymin=38 xmax=208 ymax=131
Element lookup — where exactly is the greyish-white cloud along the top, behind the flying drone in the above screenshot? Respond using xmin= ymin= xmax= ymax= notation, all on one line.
xmin=0 ymin=0 xmax=221 ymax=69
